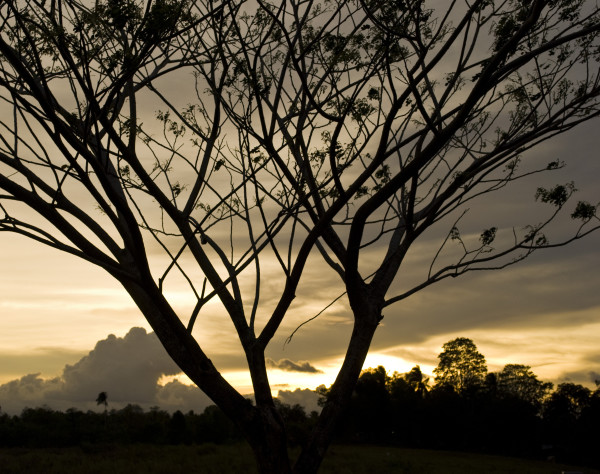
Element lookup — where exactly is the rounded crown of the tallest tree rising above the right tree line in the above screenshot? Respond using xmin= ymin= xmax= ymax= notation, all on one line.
xmin=433 ymin=337 xmax=487 ymax=393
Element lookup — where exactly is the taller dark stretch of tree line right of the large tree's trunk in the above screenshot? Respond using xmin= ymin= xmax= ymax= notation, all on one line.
xmin=321 ymin=338 xmax=600 ymax=466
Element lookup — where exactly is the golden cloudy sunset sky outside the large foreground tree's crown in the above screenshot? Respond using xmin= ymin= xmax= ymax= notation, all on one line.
xmin=0 ymin=2 xmax=600 ymax=413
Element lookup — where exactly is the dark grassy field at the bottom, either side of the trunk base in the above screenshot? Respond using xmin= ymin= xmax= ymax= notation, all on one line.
xmin=0 ymin=444 xmax=600 ymax=474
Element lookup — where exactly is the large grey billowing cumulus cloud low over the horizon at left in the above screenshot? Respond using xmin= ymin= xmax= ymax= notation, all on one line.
xmin=0 ymin=328 xmax=211 ymax=413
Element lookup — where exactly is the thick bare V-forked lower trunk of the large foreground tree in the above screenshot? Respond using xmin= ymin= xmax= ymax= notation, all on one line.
xmin=124 ymin=270 xmax=381 ymax=474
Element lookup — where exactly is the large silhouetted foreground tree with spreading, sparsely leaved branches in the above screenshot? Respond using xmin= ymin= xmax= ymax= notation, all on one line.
xmin=0 ymin=0 xmax=600 ymax=473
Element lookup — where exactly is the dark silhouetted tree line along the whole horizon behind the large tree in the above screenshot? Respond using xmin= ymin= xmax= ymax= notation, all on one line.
xmin=0 ymin=338 xmax=600 ymax=466
